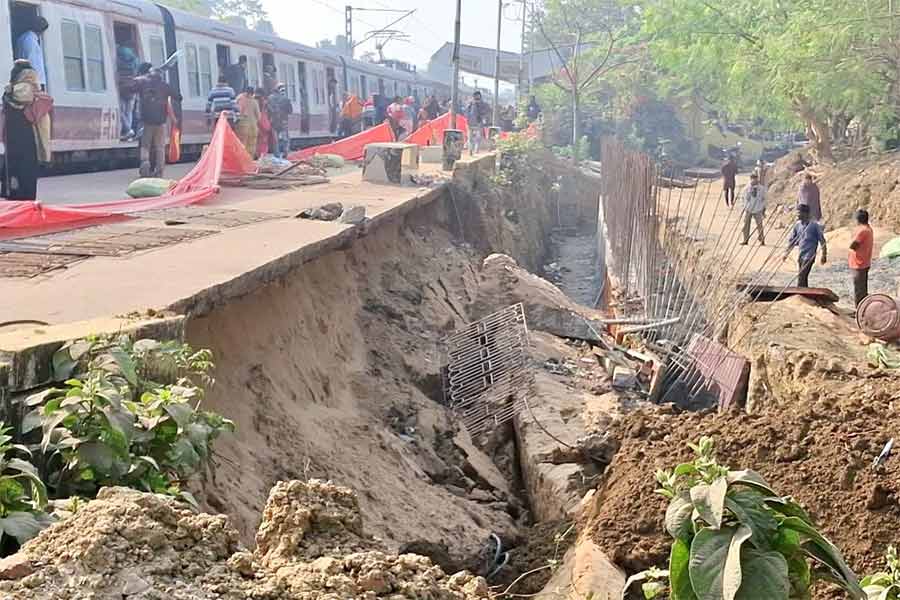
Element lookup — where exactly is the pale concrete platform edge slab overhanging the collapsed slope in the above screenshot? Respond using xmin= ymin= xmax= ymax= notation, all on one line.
xmin=0 ymin=155 xmax=492 ymax=324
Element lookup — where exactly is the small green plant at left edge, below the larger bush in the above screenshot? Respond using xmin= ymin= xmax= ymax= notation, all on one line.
xmin=0 ymin=423 xmax=51 ymax=544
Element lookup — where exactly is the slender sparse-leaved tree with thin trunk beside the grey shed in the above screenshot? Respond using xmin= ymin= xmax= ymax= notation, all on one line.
xmin=537 ymin=0 xmax=641 ymax=160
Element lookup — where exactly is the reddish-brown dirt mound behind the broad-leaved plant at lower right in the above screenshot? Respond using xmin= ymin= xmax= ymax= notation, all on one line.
xmin=590 ymin=290 xmax=900 ymax=592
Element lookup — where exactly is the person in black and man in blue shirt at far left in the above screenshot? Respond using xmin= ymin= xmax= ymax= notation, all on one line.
xmin=0 ymin=15 xmax=53 ymax=200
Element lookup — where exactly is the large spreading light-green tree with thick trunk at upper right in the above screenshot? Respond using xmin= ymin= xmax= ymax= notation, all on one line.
xmin=641 ymin=0 xmax=897 ymax=161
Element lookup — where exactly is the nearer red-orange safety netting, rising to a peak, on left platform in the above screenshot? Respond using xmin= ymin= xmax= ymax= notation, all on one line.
xmin=0 ymin=116 xmax=256 ymax=230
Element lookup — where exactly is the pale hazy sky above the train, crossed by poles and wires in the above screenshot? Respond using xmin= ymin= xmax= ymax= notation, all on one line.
xmin=262 ymin=0 xmax=522 ymax=79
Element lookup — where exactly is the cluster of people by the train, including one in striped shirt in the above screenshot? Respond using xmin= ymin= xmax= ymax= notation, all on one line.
xmin=206 ymin=56 xmax=294 ymax=159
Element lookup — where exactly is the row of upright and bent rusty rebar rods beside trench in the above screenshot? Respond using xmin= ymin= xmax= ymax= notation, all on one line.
xmin=601 ymin=138 xmax=785 ymax=406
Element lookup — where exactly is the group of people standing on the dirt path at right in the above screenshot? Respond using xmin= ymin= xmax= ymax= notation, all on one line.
xmin=721 ymin=157 xmax=874 ymax=306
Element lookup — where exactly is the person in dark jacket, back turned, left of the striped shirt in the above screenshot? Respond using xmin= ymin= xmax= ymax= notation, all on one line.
xmin=134 ymin=67 xmax=181 ymax=177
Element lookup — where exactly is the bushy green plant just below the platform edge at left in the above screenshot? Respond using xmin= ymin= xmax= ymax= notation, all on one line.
xmin=22 ymin=336 xmax=234 ymax=497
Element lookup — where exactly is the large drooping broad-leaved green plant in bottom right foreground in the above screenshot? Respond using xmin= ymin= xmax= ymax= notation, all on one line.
xmin=626 ymin=437 xmax=866 ymax=600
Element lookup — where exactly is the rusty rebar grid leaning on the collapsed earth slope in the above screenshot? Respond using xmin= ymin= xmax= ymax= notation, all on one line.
xmin=445 ymin=304 xmax=534 ymax=436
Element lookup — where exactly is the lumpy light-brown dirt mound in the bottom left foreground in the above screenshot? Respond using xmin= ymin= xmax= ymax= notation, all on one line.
xmin=0 ymin=481 xmax=488 ymax=600
